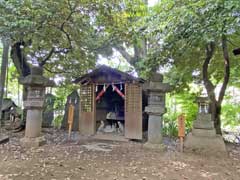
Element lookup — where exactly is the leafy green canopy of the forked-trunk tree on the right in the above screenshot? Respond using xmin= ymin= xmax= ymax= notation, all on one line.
xmin=139 ymin=0 xmax=240 ymax=88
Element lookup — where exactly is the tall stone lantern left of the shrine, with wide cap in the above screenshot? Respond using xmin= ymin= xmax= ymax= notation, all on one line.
xmin=20 ymin=66 xmax=54 ymax=147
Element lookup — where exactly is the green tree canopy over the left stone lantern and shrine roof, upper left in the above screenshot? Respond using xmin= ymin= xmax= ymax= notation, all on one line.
xmin=0 ymin=0 xmax=147 ymax=83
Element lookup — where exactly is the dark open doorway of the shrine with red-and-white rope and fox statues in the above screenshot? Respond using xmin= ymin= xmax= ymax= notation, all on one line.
xmin=96 ymin=83 xmax=125 ymax=136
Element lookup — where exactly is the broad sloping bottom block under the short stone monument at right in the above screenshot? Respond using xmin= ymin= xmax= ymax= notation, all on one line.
xmin=184 ymin=133 xmax=227 ymax=155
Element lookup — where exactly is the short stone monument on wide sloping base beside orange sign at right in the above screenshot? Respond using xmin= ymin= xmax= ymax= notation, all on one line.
xmin=184 ymin=97 xmax=226 ymax=155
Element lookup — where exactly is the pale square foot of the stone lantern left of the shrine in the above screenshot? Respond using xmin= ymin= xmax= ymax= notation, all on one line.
xmin=20 ymin=136 xmax=46 ymax=148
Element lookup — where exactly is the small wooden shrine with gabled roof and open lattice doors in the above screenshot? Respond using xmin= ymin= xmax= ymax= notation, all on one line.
xmin=75 ymin=65 xmax=144 ymax=139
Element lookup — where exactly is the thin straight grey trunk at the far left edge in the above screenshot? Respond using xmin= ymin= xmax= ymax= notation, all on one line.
xmin=0 ymin=38 xmax=10 ymax=124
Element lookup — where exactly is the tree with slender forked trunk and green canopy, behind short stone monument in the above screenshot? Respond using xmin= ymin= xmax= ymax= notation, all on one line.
xmin=140 ymin=0 xmax=240 ymax=134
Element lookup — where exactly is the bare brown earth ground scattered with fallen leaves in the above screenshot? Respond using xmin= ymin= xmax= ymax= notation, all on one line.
xmin=0 ymin=129 xmax=240 ymax=180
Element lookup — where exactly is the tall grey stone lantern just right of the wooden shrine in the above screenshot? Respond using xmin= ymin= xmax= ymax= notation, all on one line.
xmin=145 ymin=73 xmax=172 ymax=149
